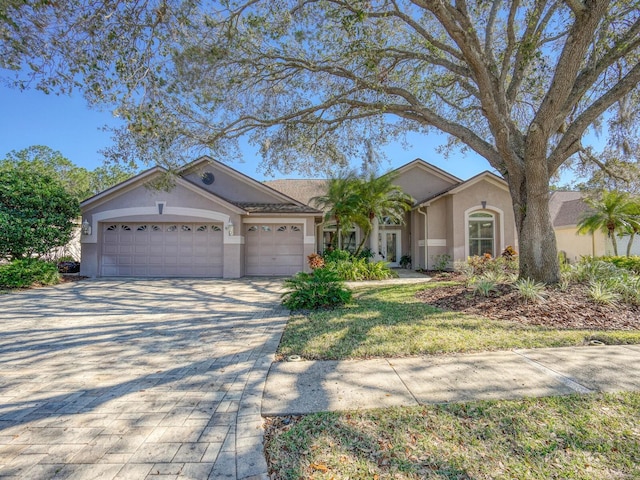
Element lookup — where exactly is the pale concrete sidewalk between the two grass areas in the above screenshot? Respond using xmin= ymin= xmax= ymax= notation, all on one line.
xmin=262 ymin=345 xmax=640 ymax=416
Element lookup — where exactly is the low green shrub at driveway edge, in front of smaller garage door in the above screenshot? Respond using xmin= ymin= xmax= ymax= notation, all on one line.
xmin=282 ymin=268 xmax=351 ymax=310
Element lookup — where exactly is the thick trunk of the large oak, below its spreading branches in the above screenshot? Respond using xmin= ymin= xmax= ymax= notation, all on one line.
xmin=509 ymin=159 xmax=560 ymax=284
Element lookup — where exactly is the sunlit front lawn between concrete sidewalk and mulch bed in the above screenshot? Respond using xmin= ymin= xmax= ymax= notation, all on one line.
xmin=279 ymin=282 xmax=640 ymax=360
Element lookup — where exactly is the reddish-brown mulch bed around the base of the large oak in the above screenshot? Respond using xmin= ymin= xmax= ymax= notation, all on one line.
xmin=416 ymin=284 xmax=640 ymax=330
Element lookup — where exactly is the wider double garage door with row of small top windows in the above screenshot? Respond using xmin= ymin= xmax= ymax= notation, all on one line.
xmin=100 ymin=223 xmax=223 ymax=277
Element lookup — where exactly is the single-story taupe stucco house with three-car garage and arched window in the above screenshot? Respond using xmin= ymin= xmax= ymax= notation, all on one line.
xmin=81 ymin=157 xmax=517 ymax=278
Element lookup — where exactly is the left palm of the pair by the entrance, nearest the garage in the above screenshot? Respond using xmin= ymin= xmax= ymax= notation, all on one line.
xmin=310 ymin=172 xmax=358 ymax=248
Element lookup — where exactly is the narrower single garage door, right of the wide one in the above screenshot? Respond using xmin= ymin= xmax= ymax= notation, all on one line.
xmin=244 ymin=224 xmax=304 ymax=275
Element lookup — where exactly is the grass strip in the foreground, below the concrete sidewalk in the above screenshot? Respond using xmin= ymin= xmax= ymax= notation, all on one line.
xmin=265 ymin=393 xmax=640 ymax=480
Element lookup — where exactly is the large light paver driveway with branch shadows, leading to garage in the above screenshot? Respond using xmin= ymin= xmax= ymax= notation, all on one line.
xmin=0 ymin=279 xmax=286 ymax=479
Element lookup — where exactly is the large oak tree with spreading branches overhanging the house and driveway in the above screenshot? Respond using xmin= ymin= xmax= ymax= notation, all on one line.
xmin=0 ymin=0 xmax=640 ymax=282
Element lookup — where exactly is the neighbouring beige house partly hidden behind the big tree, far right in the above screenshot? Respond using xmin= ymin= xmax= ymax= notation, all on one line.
xmin=549 ymin=190 xmax=640 ymax=263
